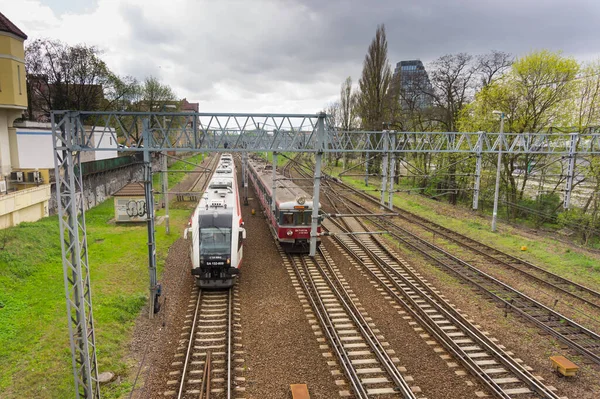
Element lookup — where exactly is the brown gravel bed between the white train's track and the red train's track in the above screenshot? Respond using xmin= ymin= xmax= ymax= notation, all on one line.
xmin=239 ymin=189 xmax=339 ymax=399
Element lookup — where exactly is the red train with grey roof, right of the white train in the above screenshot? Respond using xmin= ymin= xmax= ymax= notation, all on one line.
xmin=248 ymin=158 xmax=321 ymax=253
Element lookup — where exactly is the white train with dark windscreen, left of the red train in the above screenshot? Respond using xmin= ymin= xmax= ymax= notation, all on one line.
xmin=184 ymin=154 xmax=246 ymax=288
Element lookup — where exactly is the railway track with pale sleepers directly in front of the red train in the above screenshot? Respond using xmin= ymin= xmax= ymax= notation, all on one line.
xmin=280 ymin=248 xmax=417 ymax=399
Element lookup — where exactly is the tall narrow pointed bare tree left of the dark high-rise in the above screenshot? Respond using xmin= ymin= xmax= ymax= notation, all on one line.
xmin=358 ymin=24 xmax=392 ymax=130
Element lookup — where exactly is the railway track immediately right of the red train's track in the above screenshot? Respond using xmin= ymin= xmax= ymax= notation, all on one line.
xmin=324 ymin=218 xmax=559 ymax=399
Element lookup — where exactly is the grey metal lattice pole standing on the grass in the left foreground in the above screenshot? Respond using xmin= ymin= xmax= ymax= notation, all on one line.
xmin=52 ymin=113 xmax=100 ymax=399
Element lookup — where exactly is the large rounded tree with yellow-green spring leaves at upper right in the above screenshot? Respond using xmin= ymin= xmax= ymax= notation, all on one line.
xmin=459 ymin=50 xmax=579 ymax=216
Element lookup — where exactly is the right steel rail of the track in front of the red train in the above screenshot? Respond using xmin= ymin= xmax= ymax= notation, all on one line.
xmin=312 ymin=252 xmax=416 ymax=399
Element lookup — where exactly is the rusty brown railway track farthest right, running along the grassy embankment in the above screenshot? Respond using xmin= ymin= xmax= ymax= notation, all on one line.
xmin=334 ymin=177 xmax=600 ymax=310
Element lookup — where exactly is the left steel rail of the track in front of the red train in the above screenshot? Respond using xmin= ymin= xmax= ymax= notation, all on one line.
xmin=286 ymin=253 xmax=368 ymax=399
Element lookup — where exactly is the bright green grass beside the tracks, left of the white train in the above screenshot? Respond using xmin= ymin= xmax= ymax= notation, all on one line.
xmin=0 ymin=195 xmax=189 ymax=398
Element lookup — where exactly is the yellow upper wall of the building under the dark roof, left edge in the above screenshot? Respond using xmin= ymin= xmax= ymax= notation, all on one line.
xmin=0 ymin=32 xmax=27 ymax=109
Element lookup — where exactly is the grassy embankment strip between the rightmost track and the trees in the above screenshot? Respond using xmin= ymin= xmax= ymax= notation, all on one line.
xmin=326 ymin=167 xmax=600 ymax=290
